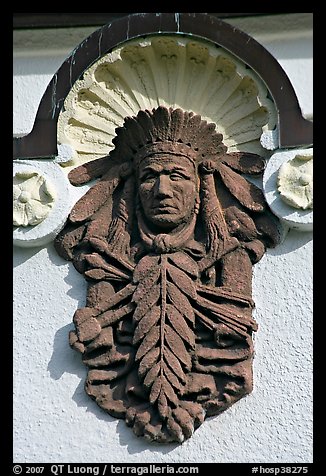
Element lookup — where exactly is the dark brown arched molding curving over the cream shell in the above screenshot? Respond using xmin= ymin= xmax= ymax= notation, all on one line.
xmin=13 ymin=13 xmax=313 ymax=159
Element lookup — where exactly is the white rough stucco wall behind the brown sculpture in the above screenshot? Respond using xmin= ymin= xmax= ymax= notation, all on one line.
xmin=13 ymin=14 xmax=313 ymax=463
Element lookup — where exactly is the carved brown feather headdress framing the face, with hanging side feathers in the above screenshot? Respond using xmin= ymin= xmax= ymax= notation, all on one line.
xmin=56 ymin=106 xmax=279 ymax=271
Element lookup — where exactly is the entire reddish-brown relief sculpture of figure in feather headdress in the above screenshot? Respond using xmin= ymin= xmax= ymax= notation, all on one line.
xmin=55 ymin=106 xmax=279 ymax=443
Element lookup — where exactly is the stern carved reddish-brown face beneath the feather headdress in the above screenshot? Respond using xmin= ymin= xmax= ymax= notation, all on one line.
xmin=138 ymin=154 xmax=198 ymax=230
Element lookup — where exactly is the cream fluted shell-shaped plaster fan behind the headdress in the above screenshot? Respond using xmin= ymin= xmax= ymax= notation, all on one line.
xmin=58 ymin=35 xmax=277 ymax=168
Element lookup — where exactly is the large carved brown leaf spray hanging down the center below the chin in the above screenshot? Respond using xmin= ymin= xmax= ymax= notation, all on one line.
xmin=133 ymin=253 xmax=197 ymax=419
